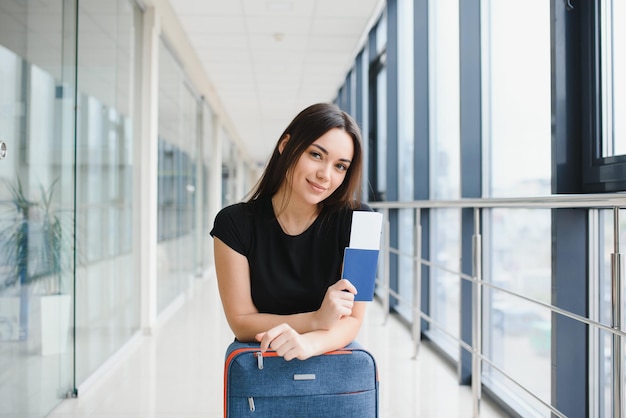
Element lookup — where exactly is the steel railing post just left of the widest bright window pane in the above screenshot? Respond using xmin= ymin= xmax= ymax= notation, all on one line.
xmin=472 ymin=208 xmax=483 ymax=418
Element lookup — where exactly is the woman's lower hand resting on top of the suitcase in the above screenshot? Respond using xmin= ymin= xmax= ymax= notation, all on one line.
xmin=256 ymin=324 xmax=315 ymax=361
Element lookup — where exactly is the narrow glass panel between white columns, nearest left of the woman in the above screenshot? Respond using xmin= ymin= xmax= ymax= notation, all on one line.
xmin=157 ymin=39 xmax=199 ymax=312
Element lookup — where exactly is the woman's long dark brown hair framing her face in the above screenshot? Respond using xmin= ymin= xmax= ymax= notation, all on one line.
xmin=250 ymin=103 xmax=363 ymax=208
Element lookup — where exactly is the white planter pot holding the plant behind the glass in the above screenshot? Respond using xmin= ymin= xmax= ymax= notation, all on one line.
xmin=41 ymin=295 xmax=72 ymax=356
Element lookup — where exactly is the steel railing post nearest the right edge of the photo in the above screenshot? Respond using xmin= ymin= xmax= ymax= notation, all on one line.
xmin=611 ymin=207 xmax=624 ymax=418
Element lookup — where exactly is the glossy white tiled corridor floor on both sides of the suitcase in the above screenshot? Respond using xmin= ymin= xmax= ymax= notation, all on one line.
xmin=48 ymin=279 xmax=505 ymax=418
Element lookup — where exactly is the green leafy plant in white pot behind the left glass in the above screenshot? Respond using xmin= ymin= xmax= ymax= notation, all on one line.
xmin=0 ymin=180 xmax=71 ymax=354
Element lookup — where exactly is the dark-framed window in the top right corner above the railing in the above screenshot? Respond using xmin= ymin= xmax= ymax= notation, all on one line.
xmin=576 ymin=0 xmax=626 ymax=193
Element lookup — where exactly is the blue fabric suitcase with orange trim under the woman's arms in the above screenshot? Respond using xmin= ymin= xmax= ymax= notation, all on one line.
xmin=224 ymin=341 xmax=378 ymax=418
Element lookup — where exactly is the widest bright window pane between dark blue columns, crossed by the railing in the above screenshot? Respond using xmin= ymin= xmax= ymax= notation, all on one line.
xmin=481 ymin=0 xmax=552 ymax=415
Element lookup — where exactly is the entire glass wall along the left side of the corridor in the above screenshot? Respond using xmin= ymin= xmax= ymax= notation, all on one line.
xmin=0 ymin=0 xmax=229 ymax=417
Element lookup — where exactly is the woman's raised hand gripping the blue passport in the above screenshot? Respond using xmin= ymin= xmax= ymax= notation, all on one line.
xmin=315 ymin=279 xmax=356 ymax=330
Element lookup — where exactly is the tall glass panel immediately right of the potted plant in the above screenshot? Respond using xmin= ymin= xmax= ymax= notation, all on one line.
xmin=76 ymin=0 xmax=141 ymax=384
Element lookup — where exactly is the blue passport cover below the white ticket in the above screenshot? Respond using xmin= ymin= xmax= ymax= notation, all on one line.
xmin=341 ymin=247 xmax=379 ymax=301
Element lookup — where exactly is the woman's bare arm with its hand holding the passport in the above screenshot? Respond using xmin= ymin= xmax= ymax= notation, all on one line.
xmin=214 ymin=237 xmax=360 ymax=342
